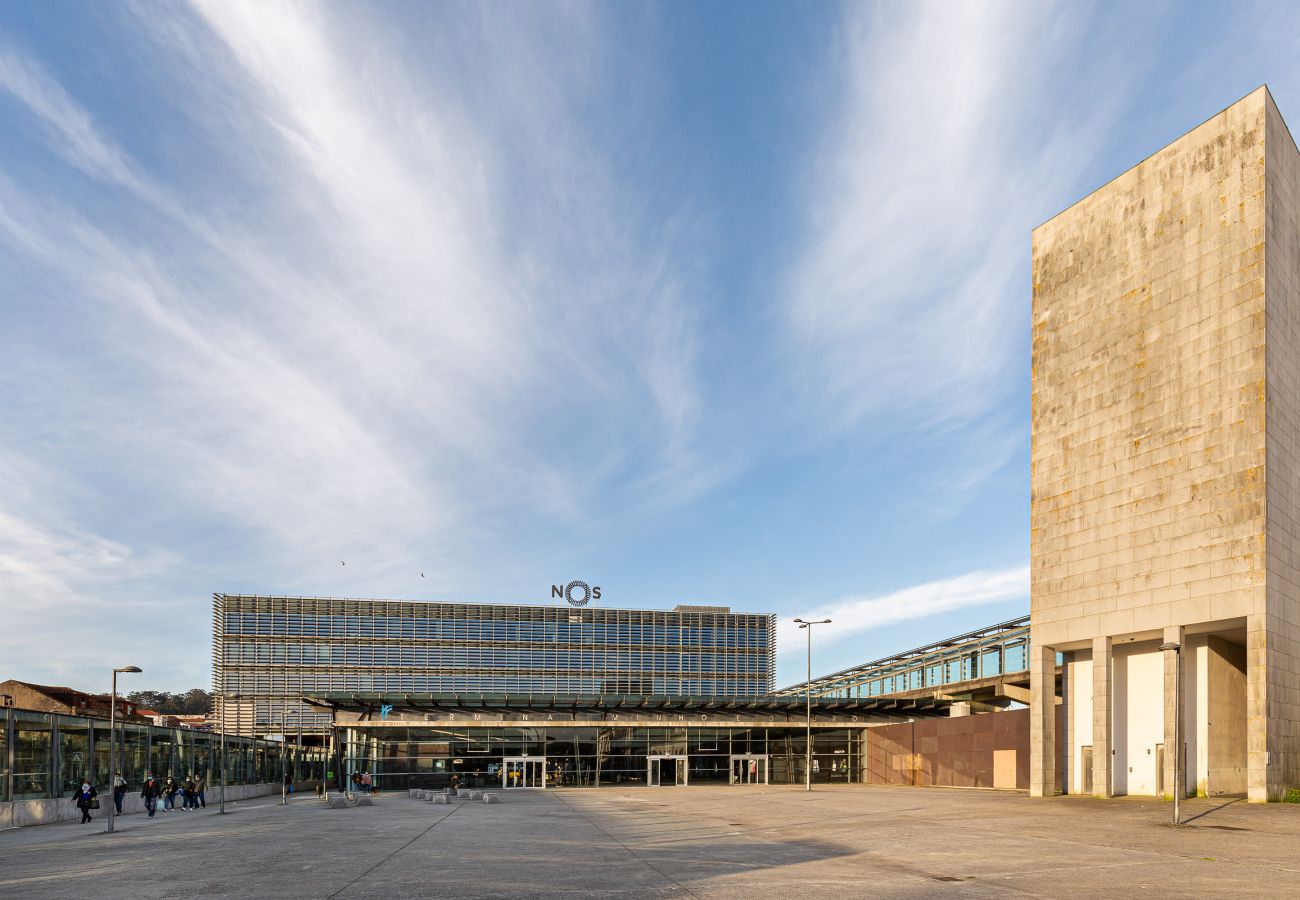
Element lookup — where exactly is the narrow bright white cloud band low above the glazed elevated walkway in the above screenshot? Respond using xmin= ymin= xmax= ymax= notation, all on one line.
xmin=776 ymin=566 xmax=1030 ymax=654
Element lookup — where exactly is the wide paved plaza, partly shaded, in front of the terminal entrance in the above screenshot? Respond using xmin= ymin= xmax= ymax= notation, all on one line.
xmin=0 ymin=787 xmax=1300 ymax=899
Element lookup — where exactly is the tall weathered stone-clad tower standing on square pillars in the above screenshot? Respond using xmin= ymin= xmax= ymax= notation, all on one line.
xmin=1031 ymin=87 xmax=1300 ymax=800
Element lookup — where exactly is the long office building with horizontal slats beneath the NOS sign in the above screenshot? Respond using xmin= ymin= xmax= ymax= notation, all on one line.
xmin=212 ymin=593 xmax=776 ymax=736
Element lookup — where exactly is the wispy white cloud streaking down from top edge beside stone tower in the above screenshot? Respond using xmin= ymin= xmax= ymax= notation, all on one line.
xmin=784 ymin=3 xmax=1127 ymax=463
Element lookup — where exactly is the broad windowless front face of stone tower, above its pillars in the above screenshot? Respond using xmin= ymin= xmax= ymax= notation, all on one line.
xmin=1031 ymin=88 xmax=1266 ymax=645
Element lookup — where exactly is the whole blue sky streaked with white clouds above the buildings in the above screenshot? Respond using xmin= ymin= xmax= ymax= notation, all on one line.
xmin=0 ymin=0 xmax=1300 ymax=689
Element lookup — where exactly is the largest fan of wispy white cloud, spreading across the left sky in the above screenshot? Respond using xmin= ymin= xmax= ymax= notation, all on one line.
xmin=0 ymin=3 xmax=711 ymax=681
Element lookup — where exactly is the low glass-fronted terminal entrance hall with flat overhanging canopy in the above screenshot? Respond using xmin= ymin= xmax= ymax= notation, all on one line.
xmin=308 ymin=693 xmax=948 ymax=791
